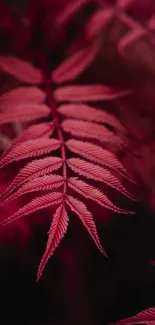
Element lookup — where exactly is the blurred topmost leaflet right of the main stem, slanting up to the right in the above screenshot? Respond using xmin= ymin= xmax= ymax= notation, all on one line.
xmin=51 ymin=43 xmax=99 ymax=84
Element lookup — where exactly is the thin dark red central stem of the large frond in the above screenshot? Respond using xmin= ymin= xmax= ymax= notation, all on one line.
xmin=39 ymin=50 xmax=67 ymax=195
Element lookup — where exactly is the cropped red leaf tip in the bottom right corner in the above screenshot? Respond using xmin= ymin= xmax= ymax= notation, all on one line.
xmin=112 ymin=307 xmax=155 ymax=325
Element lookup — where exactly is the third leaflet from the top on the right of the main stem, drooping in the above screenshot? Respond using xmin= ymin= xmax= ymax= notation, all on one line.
xmin=58 ymin=104 xmax=126 ymax=133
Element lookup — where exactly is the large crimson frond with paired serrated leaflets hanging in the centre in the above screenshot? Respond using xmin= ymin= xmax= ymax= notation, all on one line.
xmin=0 ymin=5 xmax=135 ymax=279
